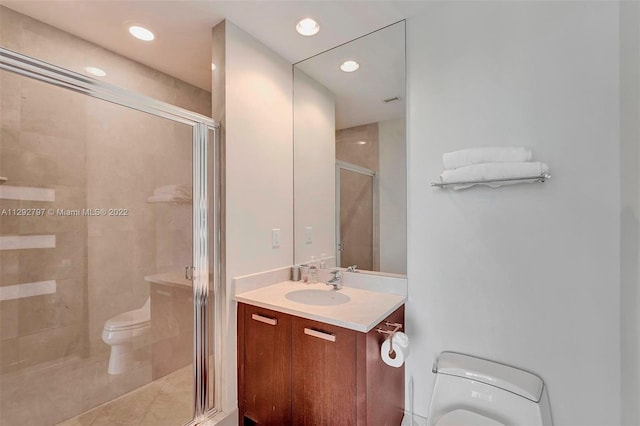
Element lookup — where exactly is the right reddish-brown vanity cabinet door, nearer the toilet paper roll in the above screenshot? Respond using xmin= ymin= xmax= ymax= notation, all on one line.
xmin=292 ymin=317 xmax=357 ymax=426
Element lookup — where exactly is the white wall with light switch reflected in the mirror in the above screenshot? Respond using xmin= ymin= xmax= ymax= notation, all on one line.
xmin=293 ymin=69 xmax=336 ymax=264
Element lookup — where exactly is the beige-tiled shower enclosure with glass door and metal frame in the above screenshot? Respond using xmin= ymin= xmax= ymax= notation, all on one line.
xmin=0 ymin=8 xmax=220 ymax=426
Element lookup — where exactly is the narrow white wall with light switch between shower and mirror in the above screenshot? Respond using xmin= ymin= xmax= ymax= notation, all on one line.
xmin=222 ymin=21 xmax=293 ymax=411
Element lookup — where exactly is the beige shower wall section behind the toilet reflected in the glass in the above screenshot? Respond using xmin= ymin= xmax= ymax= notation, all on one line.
xmin=86 ymin=99 xmax=192 ymax=353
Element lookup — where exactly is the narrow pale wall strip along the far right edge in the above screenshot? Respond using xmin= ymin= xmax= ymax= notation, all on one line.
xmin=620 ymin=1 xmax=640 ymax=425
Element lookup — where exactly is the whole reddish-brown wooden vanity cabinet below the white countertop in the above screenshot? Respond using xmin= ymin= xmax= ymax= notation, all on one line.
xmin=238 ymin=303 xmax=404 ymax=426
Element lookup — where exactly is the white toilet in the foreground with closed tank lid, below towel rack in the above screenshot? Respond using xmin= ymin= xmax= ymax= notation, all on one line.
xmin=427 ymin=352 xmax=553 ymax=426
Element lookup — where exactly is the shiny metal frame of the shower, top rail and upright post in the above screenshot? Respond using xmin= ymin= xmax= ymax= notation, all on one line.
xmin=0 ymin=47 xmax=223 ymax=425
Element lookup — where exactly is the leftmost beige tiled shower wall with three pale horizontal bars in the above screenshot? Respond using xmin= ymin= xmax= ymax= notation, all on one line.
xmin=0 ymin=71 xmax=87 ymax=373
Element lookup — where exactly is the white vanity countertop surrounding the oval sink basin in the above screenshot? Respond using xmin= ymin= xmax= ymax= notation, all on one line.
xmin=235 ymin=281 xmax=407 ymax=333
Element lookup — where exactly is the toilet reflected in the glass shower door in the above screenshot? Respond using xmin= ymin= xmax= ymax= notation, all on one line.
xmin=102 ymin=298 xmax=151 ymax=374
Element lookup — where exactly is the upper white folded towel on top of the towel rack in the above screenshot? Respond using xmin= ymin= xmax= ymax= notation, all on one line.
xmin=442 ymin=146 xmax=533 ymax=170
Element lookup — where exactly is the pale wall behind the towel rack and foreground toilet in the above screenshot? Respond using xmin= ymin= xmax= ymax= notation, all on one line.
xmin=407 ymin=2 xmax=621 ymax=425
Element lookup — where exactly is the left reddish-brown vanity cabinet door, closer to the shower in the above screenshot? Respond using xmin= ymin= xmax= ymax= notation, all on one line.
xmin=238 ymin=304 xmax=292 ymax=426
